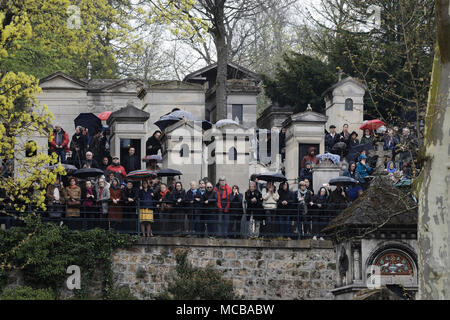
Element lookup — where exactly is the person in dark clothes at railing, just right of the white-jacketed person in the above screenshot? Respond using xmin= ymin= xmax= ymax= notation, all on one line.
xmin=277 ymin=181 xmax=295 ymax=237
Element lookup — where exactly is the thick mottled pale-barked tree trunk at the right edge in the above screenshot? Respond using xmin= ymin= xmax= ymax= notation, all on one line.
xmin=417 ymin=0 xmax=450 ymax=300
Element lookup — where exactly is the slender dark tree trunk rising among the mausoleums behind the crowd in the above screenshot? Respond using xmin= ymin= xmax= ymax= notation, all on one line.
xmin=214 ymin=1 xmax=228 ymax=121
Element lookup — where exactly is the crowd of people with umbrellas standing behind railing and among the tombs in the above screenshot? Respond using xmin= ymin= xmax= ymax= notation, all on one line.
xmin=2 ymin=125 xmax=417 ymax=239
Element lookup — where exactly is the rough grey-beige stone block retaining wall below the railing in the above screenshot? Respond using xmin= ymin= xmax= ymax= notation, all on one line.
xmin=113 ymin=238 xmax=336 ymax=300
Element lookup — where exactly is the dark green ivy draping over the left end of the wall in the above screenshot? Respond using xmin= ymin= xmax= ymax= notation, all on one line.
xmin=0 ymin=215 xmax=137 ymax=299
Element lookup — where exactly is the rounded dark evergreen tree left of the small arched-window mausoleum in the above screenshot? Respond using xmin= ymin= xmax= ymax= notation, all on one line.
xmin=263 ymin=52 xmax=336 ymax=112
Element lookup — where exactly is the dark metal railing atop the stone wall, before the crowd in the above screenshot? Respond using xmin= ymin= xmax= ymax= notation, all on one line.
xmin=0 ymin=201 xmax=348 ymax=239
